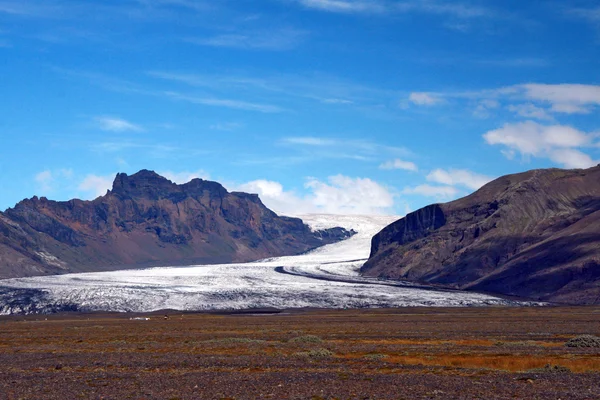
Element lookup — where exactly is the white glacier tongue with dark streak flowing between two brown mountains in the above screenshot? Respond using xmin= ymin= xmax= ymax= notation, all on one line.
xmin=0 ymin=215 xmax=528 ymax=314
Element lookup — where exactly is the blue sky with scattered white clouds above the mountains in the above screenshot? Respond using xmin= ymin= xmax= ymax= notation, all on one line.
xmin=0 ymin=0 xmax=600 ymax=214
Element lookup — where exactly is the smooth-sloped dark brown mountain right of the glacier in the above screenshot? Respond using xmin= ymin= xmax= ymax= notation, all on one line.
xmin=361 ymin=166 xmax=600 ymax=304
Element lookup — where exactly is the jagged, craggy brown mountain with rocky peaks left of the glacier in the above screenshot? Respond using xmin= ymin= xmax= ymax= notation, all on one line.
xmin=0 ymin=170 xmax=354 ymax=278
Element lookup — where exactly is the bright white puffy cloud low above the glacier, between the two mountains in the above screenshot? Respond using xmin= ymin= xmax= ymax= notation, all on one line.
xmin=236 ymin=175 xmax=394 ymax=215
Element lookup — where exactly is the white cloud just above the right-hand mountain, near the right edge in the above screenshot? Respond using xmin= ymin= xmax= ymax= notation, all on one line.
xmin=483 ymin=121 xmax=597 ymax=168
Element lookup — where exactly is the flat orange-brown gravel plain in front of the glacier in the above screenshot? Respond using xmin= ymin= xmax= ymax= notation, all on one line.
xmin=0 ymin=307 xmax=600 ymax=400
